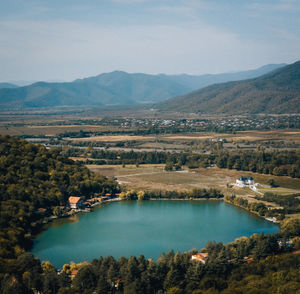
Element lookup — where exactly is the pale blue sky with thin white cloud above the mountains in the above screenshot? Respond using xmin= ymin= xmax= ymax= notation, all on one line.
xmin=0 ymin=0 xmax=300 ymax=81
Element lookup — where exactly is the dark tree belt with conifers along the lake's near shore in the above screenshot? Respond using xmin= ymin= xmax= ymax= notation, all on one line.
xmin=1 ymin=227 xmax=300 ymax=294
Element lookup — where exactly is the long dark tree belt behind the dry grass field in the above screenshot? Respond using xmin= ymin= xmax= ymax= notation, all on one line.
xmin=64 ymin=147 xmax=300 ymax=178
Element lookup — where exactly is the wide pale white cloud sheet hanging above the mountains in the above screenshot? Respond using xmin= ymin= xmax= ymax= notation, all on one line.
xmin=0 ymin=21 xmax=299 ymax=80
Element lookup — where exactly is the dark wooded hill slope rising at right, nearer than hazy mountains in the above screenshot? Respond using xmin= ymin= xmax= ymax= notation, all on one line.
xmin=155 ymin=61 xmax=300 ymax=114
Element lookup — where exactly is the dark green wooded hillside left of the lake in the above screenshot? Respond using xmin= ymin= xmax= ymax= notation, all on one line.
xmin=0 ymin=136 xmax=119 ymax=260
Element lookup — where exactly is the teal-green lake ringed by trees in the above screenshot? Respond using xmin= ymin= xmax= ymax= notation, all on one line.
xmin=32 ymin=200 xmax=279 ymax=268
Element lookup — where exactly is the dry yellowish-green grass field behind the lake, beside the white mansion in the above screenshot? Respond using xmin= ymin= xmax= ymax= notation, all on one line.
xmin=88 ymin=164 xmax=300 ymax=196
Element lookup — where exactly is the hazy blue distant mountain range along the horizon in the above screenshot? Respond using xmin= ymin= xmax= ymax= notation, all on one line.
xmin=0 ymin=64 xmax=284 ymax=109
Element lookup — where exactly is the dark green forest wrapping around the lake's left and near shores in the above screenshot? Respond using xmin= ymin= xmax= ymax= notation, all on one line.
xmin=0 ymin=136 xmax=300 ymax=294
